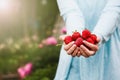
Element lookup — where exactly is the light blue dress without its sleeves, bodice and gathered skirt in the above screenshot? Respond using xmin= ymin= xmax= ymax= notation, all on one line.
xmin=55 ymin=0 xmax=120 ymax=80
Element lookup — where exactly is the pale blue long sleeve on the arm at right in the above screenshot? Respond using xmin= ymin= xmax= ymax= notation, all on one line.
xmin=93 ymin=0 xmax=120 ymax=43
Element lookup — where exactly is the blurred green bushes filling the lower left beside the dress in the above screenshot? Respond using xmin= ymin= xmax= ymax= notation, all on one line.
xmin=0 ymin=38 xmax=60 ymax=80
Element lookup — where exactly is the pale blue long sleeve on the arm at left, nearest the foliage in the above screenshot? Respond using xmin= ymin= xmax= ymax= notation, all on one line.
xmin=57 ymin=0 xmax=85 ymax=34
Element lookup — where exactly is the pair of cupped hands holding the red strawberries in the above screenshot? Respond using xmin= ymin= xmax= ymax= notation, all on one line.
xmin=60 ymin=35 xmax=100 ymax=58
